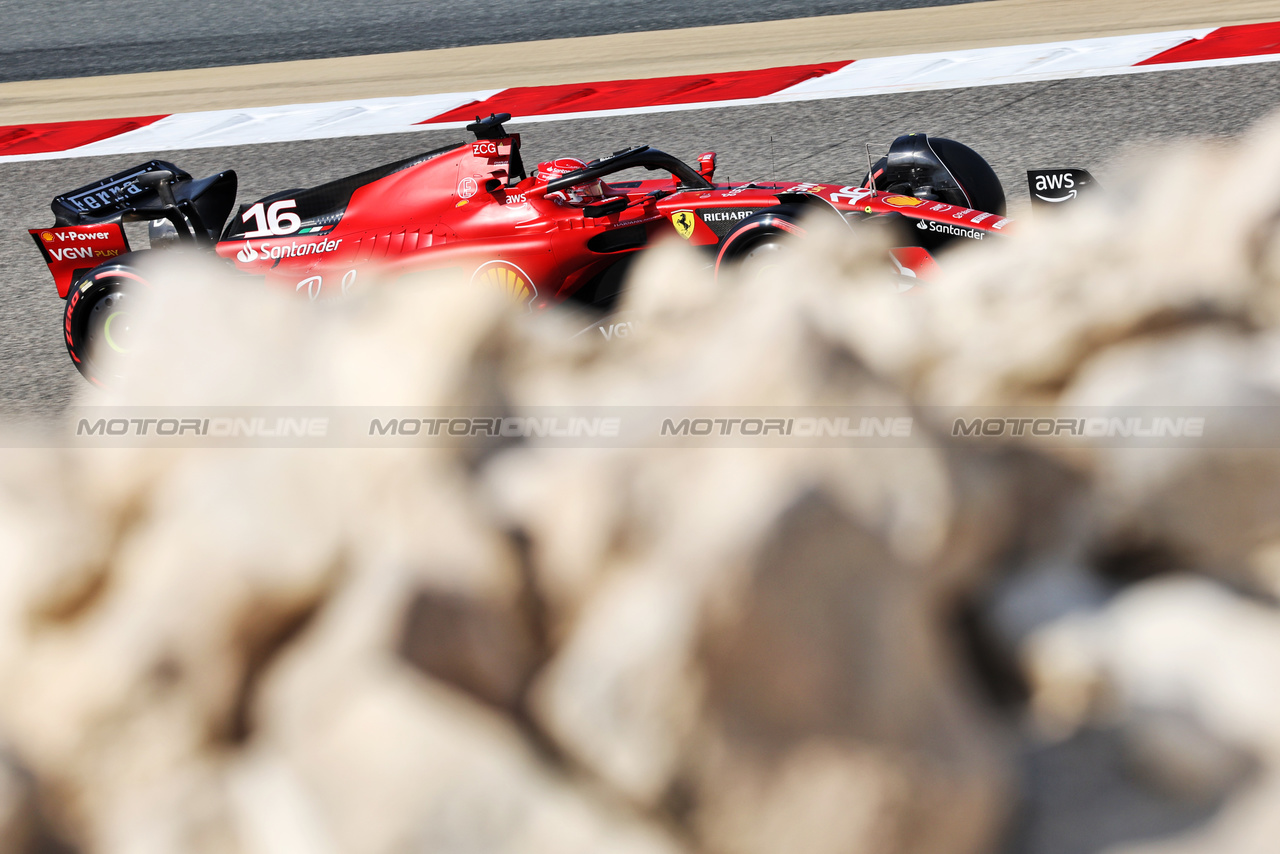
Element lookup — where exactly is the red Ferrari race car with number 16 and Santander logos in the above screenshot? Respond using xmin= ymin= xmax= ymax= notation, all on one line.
xmin=29 ymin=114 xmax=1009 ymax=384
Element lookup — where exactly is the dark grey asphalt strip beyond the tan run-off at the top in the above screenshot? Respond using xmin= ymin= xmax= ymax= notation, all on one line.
xmin=0 ymin=0 xmax=974 ymax=82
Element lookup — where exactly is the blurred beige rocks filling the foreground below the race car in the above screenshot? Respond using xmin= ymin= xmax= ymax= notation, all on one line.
xmin=12 ymin=115 xmax=1280 ymax=854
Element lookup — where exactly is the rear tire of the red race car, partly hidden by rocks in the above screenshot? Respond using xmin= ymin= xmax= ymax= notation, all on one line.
xmin=63 ymin=256 xmax=151 ymax=387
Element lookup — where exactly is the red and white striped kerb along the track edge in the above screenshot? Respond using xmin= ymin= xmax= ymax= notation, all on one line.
xmin=0 ymin=23 xmax=1280 ymax=161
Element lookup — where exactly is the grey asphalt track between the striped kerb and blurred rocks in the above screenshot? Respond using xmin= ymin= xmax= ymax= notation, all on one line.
xmin=10 ymin=57 xmax=1280 ymax=419
